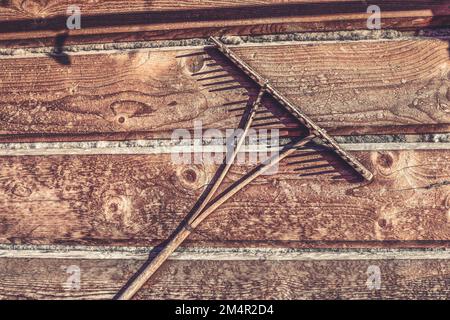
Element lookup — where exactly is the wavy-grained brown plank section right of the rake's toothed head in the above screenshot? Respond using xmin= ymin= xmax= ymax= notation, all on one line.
xmin=235 ymin=40 xmax=450 ymax=133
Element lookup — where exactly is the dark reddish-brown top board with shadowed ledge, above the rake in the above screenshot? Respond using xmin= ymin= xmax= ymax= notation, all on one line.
xmin=0 ymin=0 xmax=450 ymax=46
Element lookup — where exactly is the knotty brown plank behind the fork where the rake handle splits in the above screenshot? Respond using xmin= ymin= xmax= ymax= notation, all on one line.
xmin=0 ymin=150 xmax=450 ymax=247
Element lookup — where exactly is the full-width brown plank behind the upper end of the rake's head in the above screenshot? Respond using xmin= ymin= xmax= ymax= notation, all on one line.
xmin=0 ymin=40 xmax=450 ymax=141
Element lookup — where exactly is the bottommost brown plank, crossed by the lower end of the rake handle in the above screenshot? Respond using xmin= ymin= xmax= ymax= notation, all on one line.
xmin=0 ymin=258 xmax=450 ymax=299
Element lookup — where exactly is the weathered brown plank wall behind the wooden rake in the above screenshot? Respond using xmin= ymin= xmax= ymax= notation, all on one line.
xmin=0 ymin=0 xmax=450 ymax=299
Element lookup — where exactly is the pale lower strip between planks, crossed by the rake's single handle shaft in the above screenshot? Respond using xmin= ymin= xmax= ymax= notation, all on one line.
xmin=0 ymin=244 xmax=450 ymax=261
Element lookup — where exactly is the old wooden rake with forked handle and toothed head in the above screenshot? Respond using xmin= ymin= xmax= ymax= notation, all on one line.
xmin=115 ymin=37 xmax=373 ymax=300
